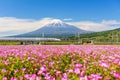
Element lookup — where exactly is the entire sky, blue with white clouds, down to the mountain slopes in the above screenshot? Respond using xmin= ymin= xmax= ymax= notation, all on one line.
xmin=0 ymin=0 xmax=120 ymax=36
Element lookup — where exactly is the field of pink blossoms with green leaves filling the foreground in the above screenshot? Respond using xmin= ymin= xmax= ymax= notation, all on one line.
xmin=0 ymin=45 xmax=120 ymax=80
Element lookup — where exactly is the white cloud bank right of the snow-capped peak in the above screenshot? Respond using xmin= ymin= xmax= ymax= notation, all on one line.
xmin=68 ymin=20 xmax=120 ymax=31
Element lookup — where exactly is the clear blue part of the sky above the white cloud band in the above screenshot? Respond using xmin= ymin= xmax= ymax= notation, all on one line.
xmin=0 ymin=0 xmax=120 ymax=21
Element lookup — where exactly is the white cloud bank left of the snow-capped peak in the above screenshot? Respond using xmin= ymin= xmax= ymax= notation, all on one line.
xmin=0 ymin=17 xmax=53 ymax=36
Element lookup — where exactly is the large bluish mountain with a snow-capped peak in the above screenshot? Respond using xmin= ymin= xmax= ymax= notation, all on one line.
xmin=15 ymin=19 xmax=89 ymax=37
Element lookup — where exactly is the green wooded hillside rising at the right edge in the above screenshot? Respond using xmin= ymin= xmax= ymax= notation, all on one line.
xmin=78 ymin=28 xmax=120 ymax=42
